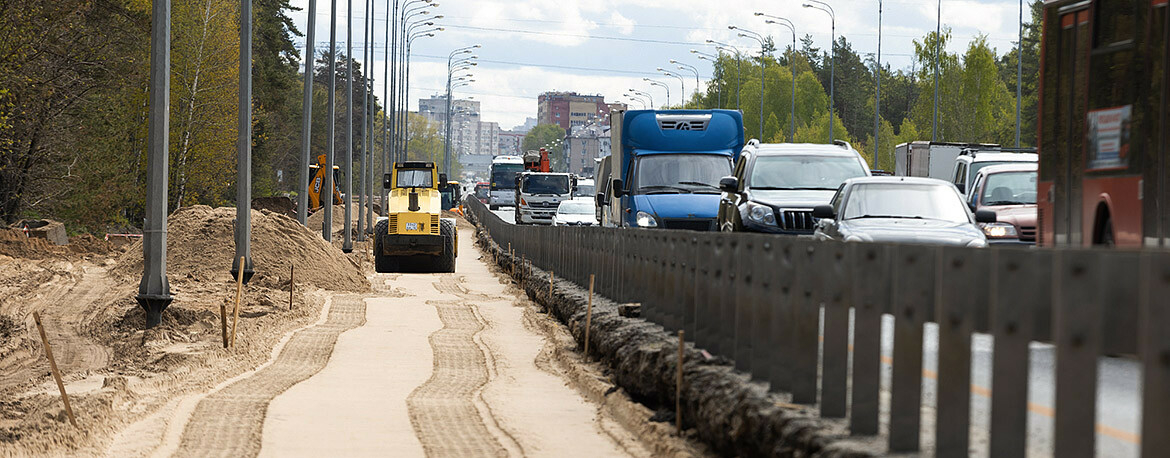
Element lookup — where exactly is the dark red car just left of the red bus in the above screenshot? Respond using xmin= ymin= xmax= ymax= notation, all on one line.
xmin=968 ymin=163 xmax=1037 ymax=245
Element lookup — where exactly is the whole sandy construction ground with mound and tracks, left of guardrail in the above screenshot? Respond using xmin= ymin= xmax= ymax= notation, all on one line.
xmin=0 ymin=206 xmax=704 ymax=457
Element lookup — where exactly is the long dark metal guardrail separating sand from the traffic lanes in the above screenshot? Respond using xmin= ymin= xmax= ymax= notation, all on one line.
xmin=468 ymin=199 xmax=1170 ymax=457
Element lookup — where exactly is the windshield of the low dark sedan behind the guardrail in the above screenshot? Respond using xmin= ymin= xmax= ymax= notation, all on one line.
xmin=841 ymin=183 xmax=971 ymax=223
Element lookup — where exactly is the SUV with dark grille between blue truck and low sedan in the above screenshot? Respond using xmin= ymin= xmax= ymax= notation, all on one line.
xmin=717 ymin=141 xmax=869 ymax=235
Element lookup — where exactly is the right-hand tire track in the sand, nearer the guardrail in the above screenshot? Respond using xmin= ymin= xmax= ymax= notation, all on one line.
xmin=406 ymin=275 xmax=523 ymax=457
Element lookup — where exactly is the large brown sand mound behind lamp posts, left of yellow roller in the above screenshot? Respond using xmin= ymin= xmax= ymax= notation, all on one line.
xmin=113 ymin=205 xmax=370 ymax=292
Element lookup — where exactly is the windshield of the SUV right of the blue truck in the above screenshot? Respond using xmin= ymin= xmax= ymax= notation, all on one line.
xmin=749 ymin=156 xmax=866 ymax=191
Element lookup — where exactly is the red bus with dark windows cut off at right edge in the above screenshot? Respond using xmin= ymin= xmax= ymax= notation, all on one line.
xmin=1037 ymin=0 xmax=1170 ymax=247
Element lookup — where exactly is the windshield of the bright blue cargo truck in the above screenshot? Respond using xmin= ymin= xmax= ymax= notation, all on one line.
xmin=634 ymin=155 xmax=731 ymax=194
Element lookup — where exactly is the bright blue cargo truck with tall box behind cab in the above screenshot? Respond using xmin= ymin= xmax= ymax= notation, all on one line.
xmin=597 ymin=110 xmax=744 ymax=231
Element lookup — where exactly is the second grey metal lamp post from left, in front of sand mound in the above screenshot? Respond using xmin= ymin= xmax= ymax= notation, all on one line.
xmin=232 ymin=0 xmax=253 ymax=283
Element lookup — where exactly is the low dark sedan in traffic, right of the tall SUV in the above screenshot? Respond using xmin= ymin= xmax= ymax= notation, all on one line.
xmin=813 ymin=177 xmax=996 ymax=247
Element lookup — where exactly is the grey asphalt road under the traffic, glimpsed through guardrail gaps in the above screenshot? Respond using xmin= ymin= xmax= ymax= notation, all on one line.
xmin=493 ymin=213 xmax=1142 ymax=457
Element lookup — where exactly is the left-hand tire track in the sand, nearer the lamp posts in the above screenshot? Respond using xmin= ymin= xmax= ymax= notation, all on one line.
xmin=176 ymin=295 xmax=365 ymax=457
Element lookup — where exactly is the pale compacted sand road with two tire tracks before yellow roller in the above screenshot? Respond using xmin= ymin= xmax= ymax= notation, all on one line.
xmin=125 ymin=227 xmax=651 ymax=457
